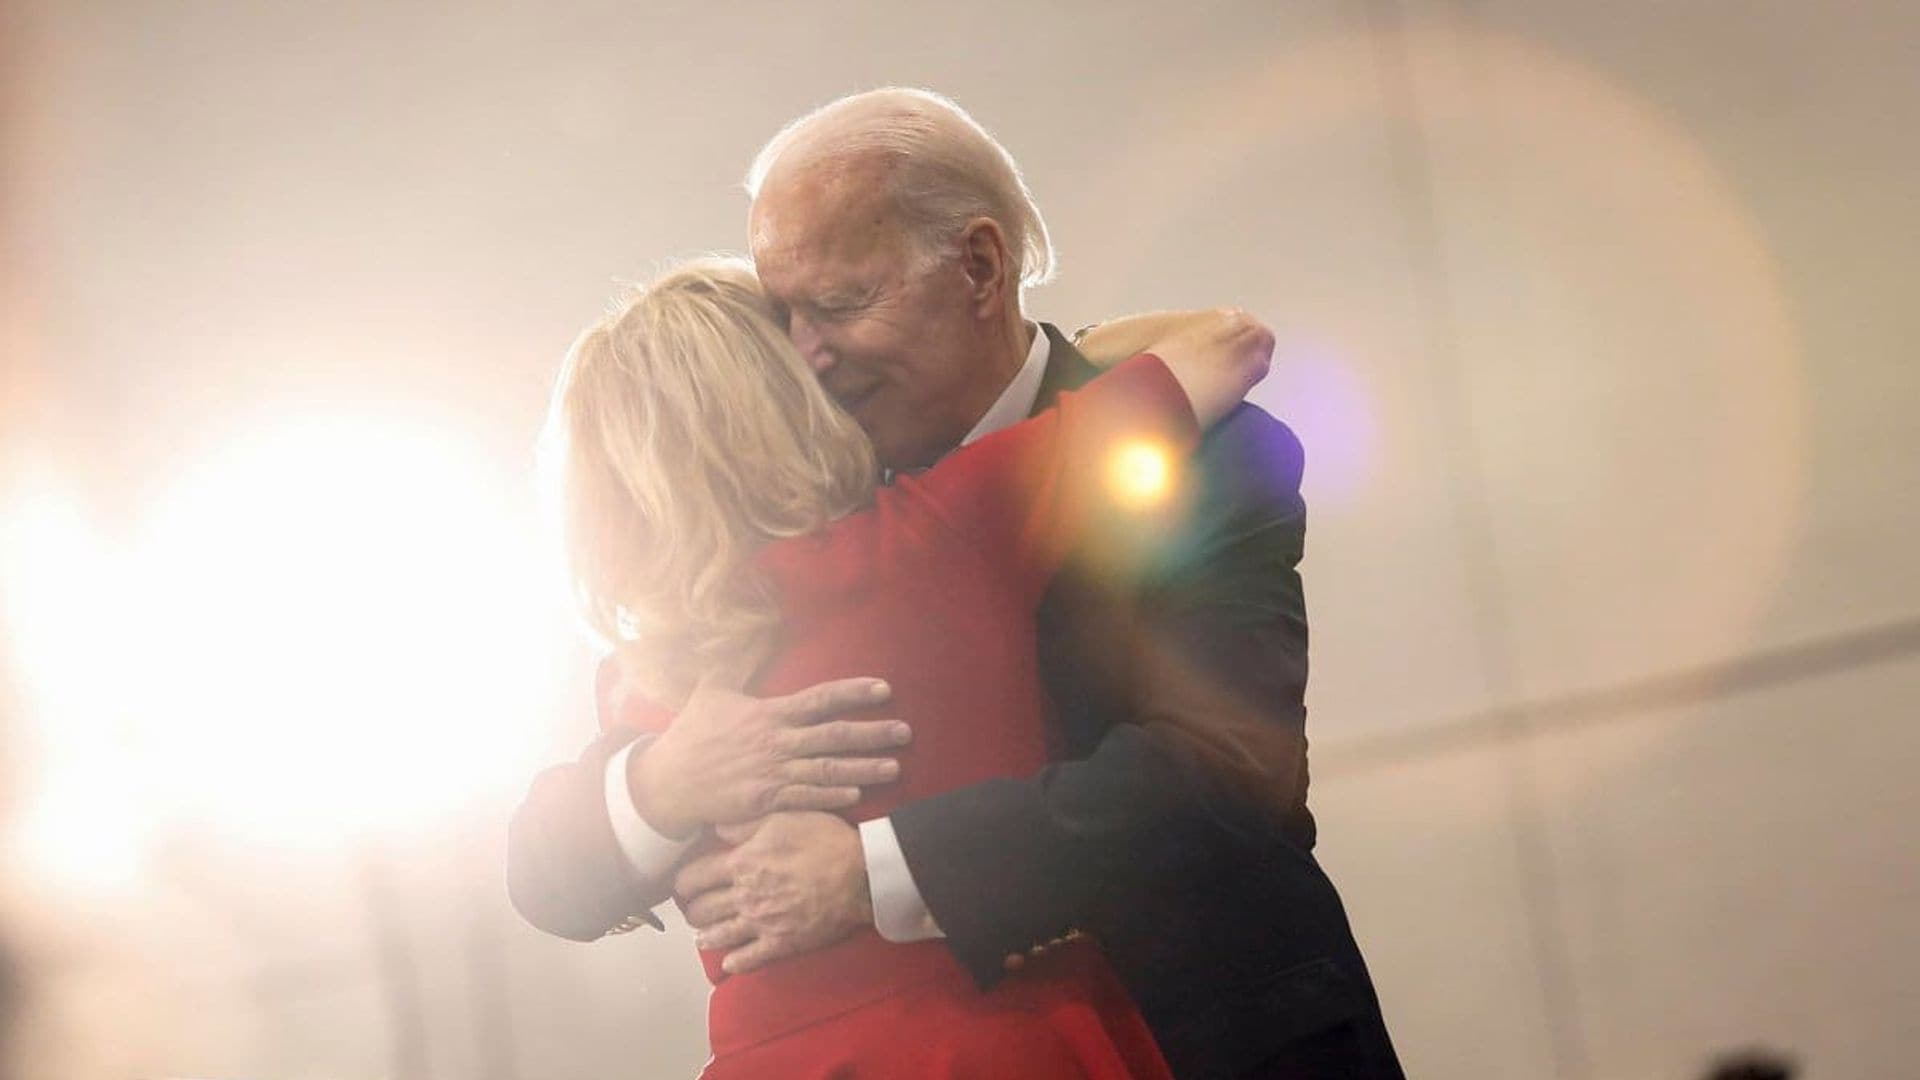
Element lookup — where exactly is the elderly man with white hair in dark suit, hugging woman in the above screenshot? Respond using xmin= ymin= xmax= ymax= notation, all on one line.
xmin=509 ymin=88 xmax=1402 ymax=1078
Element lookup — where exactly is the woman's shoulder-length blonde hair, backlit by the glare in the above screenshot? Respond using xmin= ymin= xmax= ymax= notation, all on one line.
xmin=543 ymin=258 xmax=877 ymax=707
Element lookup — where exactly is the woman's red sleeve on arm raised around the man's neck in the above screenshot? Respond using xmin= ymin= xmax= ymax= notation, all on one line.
xmin=918 ymin=352 xmax=1200 ymax=600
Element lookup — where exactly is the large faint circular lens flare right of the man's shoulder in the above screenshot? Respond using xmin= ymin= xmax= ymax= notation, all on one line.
xmin=1075 ymin=25 xmax=1812 ymax=717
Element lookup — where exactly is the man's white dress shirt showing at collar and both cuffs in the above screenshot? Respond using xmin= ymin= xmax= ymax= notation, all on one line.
xmin=607 ymin=323 xmax=1048 ymax=942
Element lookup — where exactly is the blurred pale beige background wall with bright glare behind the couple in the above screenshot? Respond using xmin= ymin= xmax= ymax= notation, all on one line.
xmin=0 ymin=0 xmax=1920 ymax=1080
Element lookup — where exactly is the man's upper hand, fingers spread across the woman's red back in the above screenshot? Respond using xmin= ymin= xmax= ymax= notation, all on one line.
xmin=628 ymin=678 xmax=912 ymax=838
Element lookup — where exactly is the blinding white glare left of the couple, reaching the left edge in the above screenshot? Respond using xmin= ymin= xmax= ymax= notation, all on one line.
xmin=4 ymin=415 xmax=564 ymax=884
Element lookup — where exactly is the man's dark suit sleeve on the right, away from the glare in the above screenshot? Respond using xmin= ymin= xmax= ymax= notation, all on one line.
xmin=893 ymin=405 xmax=1313 ymax=986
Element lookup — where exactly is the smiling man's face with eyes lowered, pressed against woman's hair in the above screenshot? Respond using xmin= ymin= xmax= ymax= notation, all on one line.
xmin=751 ymin=160 xmax=998 ymax=469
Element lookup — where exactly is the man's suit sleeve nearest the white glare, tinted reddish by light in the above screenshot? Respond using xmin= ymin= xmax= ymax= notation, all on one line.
xmin=507 ymin=657 xmax=672 ymax=942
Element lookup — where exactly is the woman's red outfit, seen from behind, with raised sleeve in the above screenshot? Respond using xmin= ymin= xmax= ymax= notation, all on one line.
xmin=603 ymin=356 xmax=1198 ymax=1080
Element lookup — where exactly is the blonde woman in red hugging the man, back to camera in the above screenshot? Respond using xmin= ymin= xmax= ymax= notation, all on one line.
xmin=549 ymin=259 xmax=1273 ymax=1080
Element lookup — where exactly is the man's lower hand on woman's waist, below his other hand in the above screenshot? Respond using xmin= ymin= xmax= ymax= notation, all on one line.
xmin=674 ymin=813 xmax=874 ymax=974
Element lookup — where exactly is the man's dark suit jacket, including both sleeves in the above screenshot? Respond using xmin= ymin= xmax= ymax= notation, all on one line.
xmin=509 ymin=327 xmax=1402 ymax=1080
